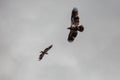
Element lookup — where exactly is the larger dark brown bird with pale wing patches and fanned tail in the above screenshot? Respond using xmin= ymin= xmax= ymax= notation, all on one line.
xmin=67 ymin=8 xmax=84 ymax=42
